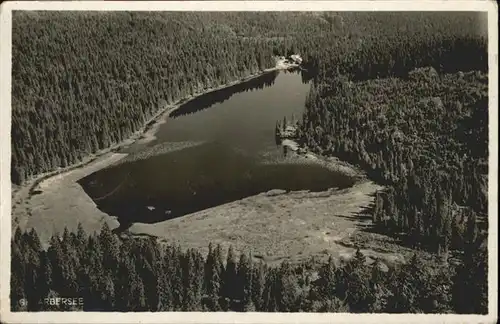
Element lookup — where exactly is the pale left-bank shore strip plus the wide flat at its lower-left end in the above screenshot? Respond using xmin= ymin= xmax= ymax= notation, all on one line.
xmin=11 ymin=65 xmax=300 ymax=238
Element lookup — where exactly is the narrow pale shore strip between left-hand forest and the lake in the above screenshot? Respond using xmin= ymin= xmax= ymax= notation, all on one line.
xmin=11 ymin=65 xmax=295 ymax=215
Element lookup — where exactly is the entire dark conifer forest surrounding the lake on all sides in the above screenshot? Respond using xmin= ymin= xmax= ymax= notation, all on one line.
xmin=11 ymin=12 xmax=489 ymax=313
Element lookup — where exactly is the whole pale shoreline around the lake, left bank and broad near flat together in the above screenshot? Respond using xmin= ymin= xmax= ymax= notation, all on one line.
xmin=11 ymin=60 xmax=390 ymax=263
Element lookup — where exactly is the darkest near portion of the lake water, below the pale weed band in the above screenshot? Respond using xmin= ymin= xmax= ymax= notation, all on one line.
xmin=79 ymin=142 xmax=353 ymax=229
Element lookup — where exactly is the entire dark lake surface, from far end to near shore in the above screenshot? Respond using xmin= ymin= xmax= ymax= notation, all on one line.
xmin=79 ymin=71 xmax=353 ymax=228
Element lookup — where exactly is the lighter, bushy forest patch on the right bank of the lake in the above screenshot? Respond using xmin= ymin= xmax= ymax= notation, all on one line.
xmin=301 ymin=68 xmax=488 ymax=252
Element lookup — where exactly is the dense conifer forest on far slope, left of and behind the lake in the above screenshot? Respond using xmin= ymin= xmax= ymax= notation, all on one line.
xmin=11 ymin=11 xmax=487 ymax=185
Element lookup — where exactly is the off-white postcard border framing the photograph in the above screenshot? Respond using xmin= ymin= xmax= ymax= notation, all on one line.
xmin=0 ymin=0 xmax=498 ymax=324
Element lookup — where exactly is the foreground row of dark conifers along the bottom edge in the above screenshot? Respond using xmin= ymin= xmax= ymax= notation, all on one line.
xmin=11 ymin=222 xmax=487 ymax=314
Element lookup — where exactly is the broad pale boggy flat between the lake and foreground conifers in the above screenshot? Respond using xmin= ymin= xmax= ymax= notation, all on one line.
xmin=127 ymin=181 xmax=396 ymax=264
